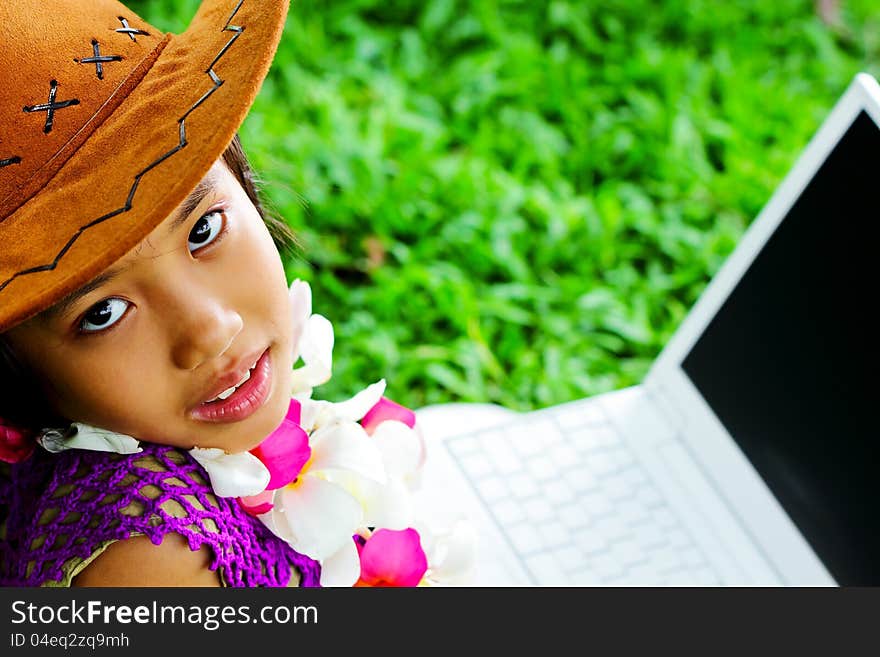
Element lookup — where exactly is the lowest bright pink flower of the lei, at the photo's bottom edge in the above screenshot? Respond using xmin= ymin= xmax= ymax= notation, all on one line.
xmin=355 ymin=528 xmax=428 ymax=586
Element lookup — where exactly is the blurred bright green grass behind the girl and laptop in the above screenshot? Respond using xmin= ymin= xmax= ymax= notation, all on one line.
xmin=130 ymin=0 xmax=880 ymax=410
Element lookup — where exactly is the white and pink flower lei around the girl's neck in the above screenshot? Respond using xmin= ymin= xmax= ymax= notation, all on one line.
xmin=0 ymin=279 xmax=473 ymax=586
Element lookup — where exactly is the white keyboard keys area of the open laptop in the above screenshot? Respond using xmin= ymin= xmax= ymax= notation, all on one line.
xmin=447 ymin=407 xmax=720 ymax=586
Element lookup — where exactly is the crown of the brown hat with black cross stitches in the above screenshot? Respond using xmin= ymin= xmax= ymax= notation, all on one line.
xmin=0 ymin=0 xmax=163 ymax=221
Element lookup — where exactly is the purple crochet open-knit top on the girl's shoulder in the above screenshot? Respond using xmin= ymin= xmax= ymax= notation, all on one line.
xmin=0 ymin=443 xmax=320 ymax=587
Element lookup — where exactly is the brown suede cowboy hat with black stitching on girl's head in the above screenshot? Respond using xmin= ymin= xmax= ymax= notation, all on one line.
xmin=0 ymin=0 xmax=288 ymax=332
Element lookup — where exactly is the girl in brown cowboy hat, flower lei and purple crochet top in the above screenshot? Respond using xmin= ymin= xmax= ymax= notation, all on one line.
xmin=0 ymin=0 xmax=458 ymax=586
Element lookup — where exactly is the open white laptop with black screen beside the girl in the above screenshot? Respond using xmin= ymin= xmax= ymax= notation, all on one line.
xmin=419 ymin=74 xmax=880 ymax=586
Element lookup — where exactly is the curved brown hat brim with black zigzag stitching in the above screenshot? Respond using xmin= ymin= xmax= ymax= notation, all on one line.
xmin=0 ymin=0 xmax=288 ymax=332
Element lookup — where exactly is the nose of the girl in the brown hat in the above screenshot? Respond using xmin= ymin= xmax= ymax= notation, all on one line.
xmin=169 ymin=298 xmax=244 ymax=370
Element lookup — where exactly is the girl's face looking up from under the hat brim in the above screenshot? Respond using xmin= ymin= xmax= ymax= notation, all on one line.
xmin=7 ymin=161 xmax=301 ymax=452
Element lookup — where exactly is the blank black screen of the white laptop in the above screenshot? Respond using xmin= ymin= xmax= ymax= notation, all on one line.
xmin=682 ymin=112 xmax=880 ymax=585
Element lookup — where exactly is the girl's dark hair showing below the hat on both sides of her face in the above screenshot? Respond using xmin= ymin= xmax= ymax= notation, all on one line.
xmin=0 ymin=135 xmax=298 ymax=431
